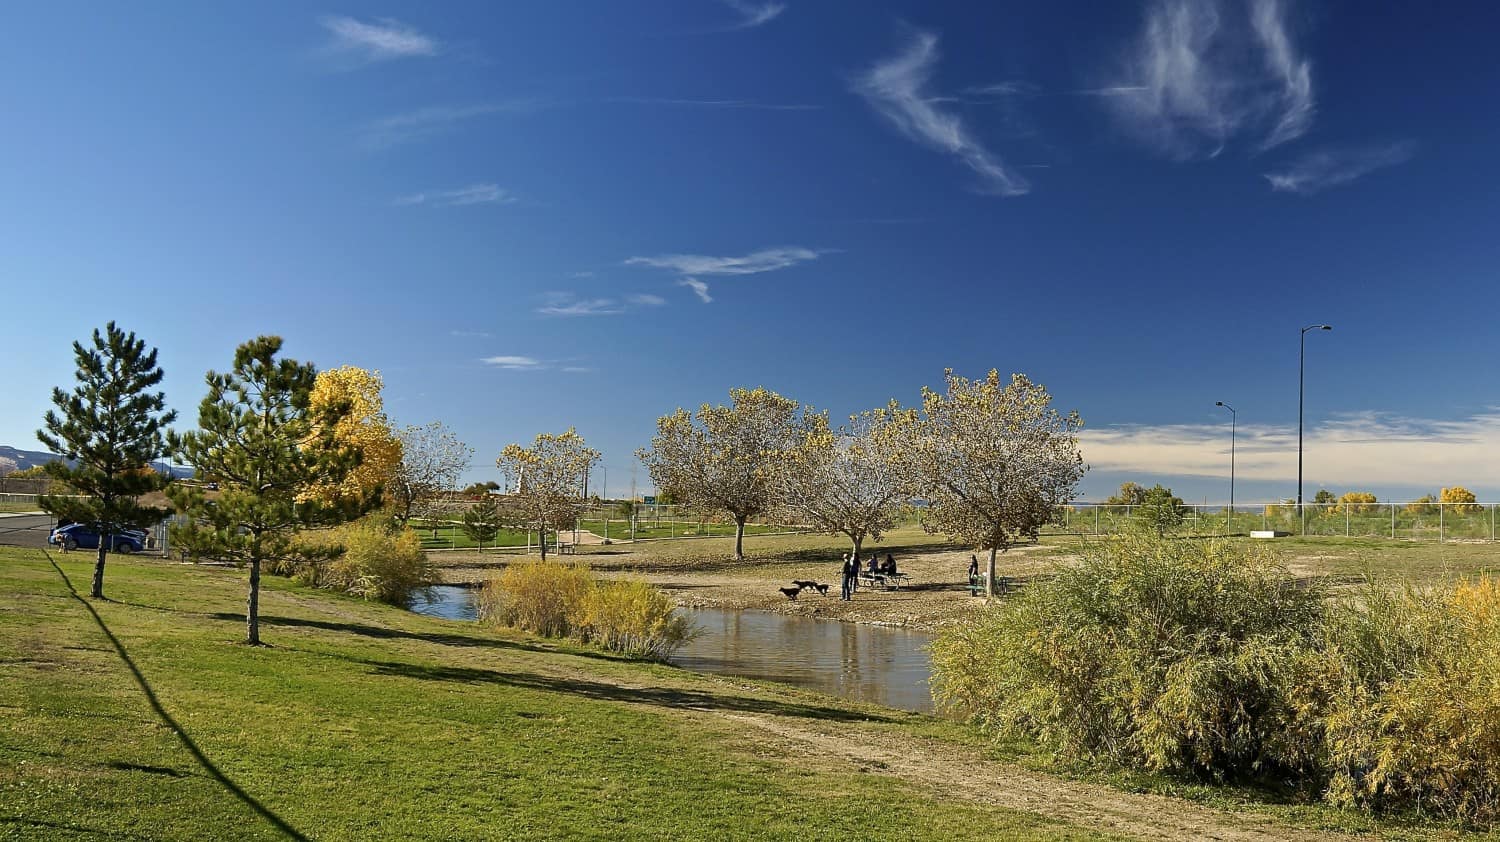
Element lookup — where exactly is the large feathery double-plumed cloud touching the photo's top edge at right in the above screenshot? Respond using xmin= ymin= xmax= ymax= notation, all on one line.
xmin=1104 ymin=0 xmax=1317 ymax=159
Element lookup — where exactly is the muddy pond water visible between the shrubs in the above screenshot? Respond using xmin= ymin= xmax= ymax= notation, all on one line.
xmin=411 ymin=585 xmax=933 ymax=711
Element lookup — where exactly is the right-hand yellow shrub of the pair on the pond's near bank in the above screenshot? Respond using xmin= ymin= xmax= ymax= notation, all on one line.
xmin=578 ymin=579 xmax=695 ymax=660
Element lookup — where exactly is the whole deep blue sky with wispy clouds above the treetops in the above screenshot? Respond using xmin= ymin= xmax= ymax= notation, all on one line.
xmin=0 ymin=0 xmax=1500 ymax=501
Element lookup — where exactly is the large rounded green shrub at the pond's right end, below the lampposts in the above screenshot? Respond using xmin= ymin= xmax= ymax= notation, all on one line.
xmin=933 ymin=534 xmax=1323 ymax=777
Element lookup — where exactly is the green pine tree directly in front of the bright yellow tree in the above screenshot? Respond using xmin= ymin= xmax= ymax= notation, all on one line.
xmin=170 ymin=336 xmax=360 ymax=645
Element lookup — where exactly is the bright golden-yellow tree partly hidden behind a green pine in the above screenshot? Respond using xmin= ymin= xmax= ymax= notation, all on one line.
xmin=303 ymin=366 xmax=401 ymax=501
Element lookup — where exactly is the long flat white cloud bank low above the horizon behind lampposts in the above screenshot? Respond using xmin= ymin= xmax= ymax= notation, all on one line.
xmin=1079 ymin=408 xmax=1500 ymax=489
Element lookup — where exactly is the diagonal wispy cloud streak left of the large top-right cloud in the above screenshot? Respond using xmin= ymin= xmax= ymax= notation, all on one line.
xmin=854 ymin=32 xmax=1031 ymax=195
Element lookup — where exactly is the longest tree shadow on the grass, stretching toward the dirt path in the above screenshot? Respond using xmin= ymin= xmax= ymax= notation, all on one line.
xmin=360 ymin=660 xmax=891 ymax=722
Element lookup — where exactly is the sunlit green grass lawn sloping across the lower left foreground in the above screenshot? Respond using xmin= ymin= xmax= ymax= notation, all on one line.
xmin=0 ymin=548 xmax=1116 ymax=840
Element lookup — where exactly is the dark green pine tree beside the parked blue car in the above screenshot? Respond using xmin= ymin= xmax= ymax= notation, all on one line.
xmin=36 ymin=321 xmax=177 ymax=599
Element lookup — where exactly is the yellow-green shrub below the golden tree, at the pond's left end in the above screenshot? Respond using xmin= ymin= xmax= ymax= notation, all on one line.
xmin=292 ymin=516 xmax=437 ymax=605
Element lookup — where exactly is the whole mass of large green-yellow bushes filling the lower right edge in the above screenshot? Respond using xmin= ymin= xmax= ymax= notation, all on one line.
xmin=933 ymin=534 xmax=1500 ymax=824
